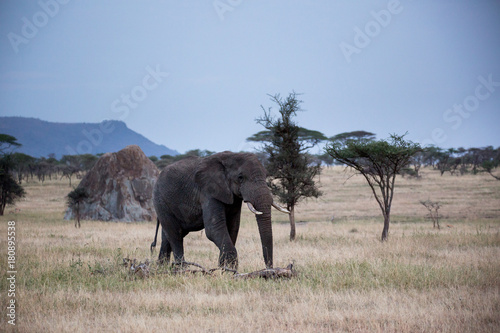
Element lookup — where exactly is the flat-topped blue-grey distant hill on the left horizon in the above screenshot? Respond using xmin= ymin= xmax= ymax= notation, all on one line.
xmin=0 ymin=117 xmax=179 ymax=159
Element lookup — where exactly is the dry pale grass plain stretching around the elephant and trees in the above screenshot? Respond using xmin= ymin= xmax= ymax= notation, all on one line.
xmin=0 ymin=167 xmax=500 ymax=332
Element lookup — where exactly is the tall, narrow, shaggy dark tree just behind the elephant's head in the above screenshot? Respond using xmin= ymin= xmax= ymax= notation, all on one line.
xmin=247 ymin=92 xmax=326 ymax=241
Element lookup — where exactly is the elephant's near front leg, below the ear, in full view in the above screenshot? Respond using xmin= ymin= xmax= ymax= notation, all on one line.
xmin=203 ymin=199 xmax=238 ymax=269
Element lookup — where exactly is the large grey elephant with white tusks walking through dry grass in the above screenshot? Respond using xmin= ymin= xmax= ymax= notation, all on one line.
xmin=151 ymin=151 xmax=289 ymax=269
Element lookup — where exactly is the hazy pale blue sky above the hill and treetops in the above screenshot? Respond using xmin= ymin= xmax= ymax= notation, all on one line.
xmin=0 ymin=0 xmax=500 ymax=152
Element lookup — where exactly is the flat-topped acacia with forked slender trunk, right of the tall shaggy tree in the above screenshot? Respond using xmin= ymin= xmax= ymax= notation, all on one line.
xmin=325 ymin=134 xmax=421 ymax=241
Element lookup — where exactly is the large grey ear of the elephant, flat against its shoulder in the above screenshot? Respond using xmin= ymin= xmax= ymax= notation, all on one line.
xmin=194 ymin=156 xmax=233 ymax=205
